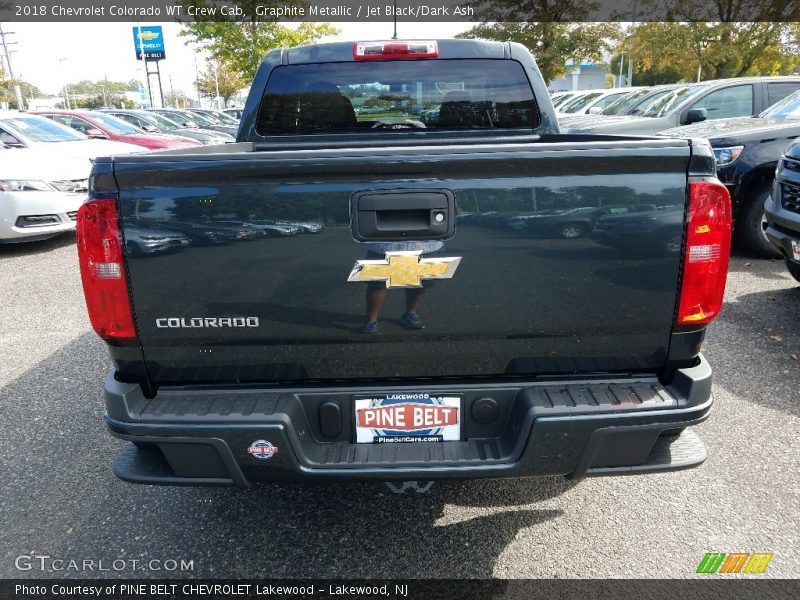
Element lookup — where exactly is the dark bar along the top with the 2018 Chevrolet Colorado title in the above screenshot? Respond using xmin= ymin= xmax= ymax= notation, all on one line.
xmin=0 ymin=0 xmax=800 ymax=23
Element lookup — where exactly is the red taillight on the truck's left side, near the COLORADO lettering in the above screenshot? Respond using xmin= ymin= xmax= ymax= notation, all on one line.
xmin=76 ymin=198 xmax=136 ymax=341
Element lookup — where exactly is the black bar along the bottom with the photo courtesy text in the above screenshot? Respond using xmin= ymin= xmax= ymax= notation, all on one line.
xmin=0 ymin=575 xmax=800 ymax=600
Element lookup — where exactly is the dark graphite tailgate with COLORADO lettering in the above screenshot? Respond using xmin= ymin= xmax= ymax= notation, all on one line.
xmin=114 ymin=136 xmax=691 ymax=384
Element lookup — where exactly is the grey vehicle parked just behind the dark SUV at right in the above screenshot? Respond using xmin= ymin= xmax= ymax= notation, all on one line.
xmin=564 ymin=77 xmax=800 ymax=135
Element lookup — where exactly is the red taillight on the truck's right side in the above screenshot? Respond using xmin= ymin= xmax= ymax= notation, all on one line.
xmin=677 ymin=181 xmax=731 ymax=325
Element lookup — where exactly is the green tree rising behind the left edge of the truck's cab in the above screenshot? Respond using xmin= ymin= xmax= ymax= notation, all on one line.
xmin=180 ymin=0 xmax=338 ymax=82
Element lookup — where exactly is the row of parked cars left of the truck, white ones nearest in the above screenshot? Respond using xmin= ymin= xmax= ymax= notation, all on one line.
xmin=0 ymin=108 xmax=241 ymax=243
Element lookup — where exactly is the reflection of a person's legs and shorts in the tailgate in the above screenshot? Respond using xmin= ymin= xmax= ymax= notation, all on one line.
xmin=361 ymin=242 xmax=444 ymax=333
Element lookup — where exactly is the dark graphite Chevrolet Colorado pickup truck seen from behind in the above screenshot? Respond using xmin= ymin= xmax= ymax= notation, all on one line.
xmin=78 ymin=40 xmax=731 ymax=491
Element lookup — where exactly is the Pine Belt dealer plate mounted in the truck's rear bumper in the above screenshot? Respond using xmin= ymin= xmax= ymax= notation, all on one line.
xmin=354 ymin=394 xmax=462 ymax=444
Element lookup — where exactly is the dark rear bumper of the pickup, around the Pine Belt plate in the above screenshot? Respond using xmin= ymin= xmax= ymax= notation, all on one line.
xmin=105 ymin=358 xmax=712 ymax=487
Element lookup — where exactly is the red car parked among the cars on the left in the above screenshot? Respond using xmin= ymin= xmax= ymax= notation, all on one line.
xmin=32 ymin=110 xmax=200 ymax=150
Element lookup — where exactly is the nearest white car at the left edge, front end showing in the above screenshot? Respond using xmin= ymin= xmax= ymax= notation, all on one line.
xmin=0 ymin=145 xmax=90 ymax=243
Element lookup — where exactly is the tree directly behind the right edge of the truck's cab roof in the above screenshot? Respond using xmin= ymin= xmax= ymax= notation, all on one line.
xmin=458 ymin=21 xmax=620 ymax=81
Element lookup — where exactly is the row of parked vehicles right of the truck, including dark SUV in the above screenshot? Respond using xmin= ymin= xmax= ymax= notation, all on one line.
xmin=552 ymin=77 xmax=800 ymax=258
